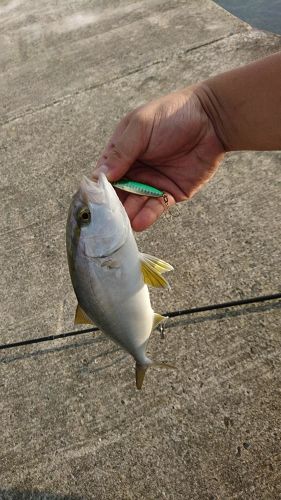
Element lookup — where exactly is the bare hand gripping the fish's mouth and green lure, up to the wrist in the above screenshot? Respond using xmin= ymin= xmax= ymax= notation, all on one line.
xmin=93 ymin=87 xmax=224 ymax=231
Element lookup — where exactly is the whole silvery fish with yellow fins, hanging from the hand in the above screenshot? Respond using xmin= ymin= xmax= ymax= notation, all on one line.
xmin=66 ymin=173 xmax=174 ymax=389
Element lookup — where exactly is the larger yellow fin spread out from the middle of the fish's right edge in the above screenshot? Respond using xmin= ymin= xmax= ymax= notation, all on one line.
xmin=140 ymin=253 xmax=173 ymax=288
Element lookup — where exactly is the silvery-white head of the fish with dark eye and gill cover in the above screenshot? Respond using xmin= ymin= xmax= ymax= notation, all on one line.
xmin=66 ymin=173 xmax=130 ymax=264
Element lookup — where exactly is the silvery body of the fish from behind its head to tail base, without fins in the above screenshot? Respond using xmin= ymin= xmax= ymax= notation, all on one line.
xmin=74 ymin=236 xmax=154 ymax=363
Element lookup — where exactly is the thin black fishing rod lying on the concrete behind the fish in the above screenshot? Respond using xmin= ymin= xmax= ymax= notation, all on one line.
xmin=0 ymin=293 xmax=281 ymax=350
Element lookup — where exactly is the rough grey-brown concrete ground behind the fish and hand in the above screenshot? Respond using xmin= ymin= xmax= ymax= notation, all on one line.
xmin=0 ymin=0 xmax=281 ymax=500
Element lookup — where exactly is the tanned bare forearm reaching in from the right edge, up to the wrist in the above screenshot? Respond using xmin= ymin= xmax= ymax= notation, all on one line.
xmin=195 ymin=52 xmax=281 ymax=151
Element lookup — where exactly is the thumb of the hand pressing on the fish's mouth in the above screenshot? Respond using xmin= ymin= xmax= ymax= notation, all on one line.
xmin=93 ymin=117 xmax=146 ymax=182
